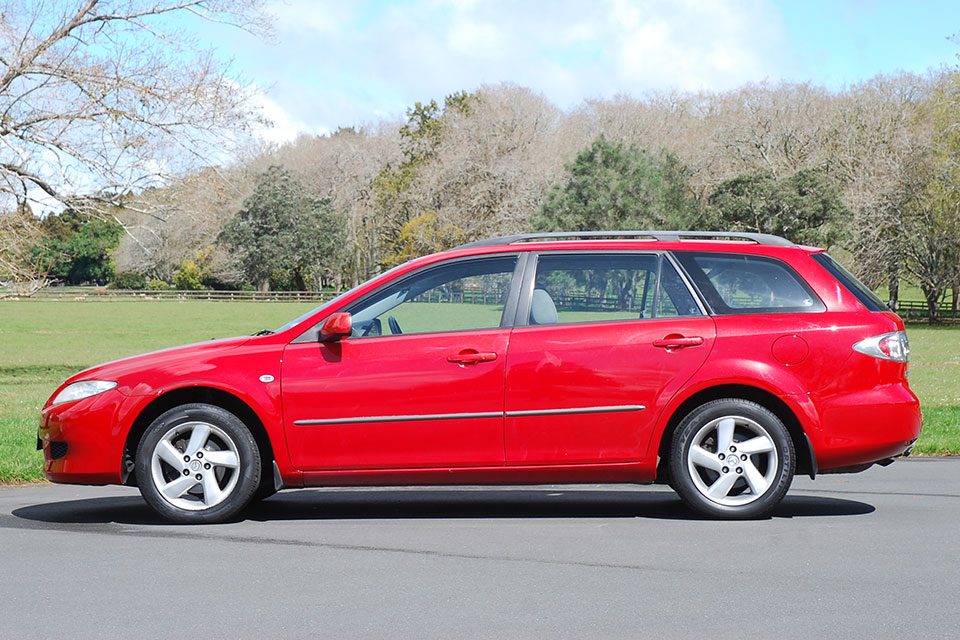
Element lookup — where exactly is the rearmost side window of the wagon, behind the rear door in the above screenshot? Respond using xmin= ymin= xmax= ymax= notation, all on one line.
xmin=675 ymin=251 xmax=826 ymax=315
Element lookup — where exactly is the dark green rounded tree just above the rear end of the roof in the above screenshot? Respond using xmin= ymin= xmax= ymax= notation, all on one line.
xmin=705 ymin=169 xmax=849 ymax=247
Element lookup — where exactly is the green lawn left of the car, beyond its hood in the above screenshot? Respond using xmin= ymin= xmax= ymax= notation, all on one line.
xmin=0 ymin=300 xmax=316 ymax=483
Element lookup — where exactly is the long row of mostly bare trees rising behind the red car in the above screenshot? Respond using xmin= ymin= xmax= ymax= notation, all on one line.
xmin=97 ymin=75 xmax=960 ymax=318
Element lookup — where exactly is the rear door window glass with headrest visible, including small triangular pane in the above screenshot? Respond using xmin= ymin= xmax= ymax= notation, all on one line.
xmin=529 ymin=254 xmax=699 ymax=325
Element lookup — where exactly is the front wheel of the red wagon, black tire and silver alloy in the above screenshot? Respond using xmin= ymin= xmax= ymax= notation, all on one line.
xmin=136 ymin=403 xmax=261 ymax=524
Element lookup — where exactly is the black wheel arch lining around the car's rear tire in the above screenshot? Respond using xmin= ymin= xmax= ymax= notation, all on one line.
xmin=657 ymin=384 xmax=817 ymax=481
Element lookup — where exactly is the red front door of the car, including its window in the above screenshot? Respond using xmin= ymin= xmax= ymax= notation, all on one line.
xmin=282 ymin=256 xmax=517 ymax=471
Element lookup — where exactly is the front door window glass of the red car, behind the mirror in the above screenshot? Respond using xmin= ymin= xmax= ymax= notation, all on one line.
xmin=346 ymin=256 xmax=517 ymax=338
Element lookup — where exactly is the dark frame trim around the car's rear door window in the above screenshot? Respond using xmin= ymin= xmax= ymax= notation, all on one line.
xmin=514 ymin=249 xmax=709 ymax=328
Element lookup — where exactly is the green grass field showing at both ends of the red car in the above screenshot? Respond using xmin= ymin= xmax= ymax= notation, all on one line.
xmin=0 ymin=301 xmax=960 ymax=483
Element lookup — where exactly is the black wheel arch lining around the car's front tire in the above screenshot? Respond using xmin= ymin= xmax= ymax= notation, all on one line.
xmin=121 ymin=387 xmax=275 ymax=486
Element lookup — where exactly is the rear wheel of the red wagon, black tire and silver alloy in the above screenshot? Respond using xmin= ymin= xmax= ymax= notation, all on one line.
xmin=670 ymin=398 xmax=796 ymax=520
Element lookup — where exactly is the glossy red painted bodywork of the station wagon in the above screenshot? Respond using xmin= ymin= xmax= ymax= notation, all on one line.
xmin=40 ymin=241 xmax=920 ymax=486
